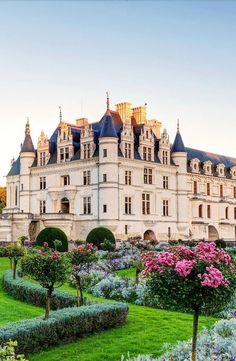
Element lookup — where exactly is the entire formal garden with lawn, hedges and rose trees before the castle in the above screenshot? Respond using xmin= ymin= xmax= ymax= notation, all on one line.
xmin=0 ymin=227 xmax=236 ymax=361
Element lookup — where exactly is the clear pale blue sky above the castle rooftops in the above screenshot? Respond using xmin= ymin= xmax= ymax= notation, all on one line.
xmin=0 ymin=0 xmax=236 ymax=185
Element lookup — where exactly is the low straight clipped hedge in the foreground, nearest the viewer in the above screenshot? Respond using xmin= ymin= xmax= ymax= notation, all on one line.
xmin=0 ymin=302 xmax=128 ymax=354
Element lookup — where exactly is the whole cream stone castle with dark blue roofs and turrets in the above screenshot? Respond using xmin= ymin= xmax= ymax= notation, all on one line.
xmin=0 ymin=99 xmax=236 ymax=241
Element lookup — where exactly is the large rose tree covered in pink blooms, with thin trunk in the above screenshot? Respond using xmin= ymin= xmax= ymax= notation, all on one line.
xmin=142 ymin=242 xmax=236 ymax=361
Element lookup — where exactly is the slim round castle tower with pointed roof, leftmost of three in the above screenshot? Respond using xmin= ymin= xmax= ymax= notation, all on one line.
xmin=19 ymin=120 xmax=35 ymax=213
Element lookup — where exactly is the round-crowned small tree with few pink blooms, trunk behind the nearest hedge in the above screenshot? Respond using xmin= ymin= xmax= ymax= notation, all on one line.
xmin=21 ymin=243 xmax=70 ymax=320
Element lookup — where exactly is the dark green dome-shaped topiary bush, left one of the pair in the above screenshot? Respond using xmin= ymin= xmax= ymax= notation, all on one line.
xmin=35 ymin=227 xmax=68 ymax=252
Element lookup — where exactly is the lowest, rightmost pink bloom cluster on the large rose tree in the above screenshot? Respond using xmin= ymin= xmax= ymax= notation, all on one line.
xmin=198 ymin=266 xmax=229 ymax=288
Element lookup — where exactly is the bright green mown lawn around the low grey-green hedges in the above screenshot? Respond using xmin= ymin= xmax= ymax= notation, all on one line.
xmin=0 ymin=258 xmax=216 ymax=361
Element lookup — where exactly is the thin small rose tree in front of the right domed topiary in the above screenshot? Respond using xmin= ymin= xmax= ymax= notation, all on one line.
xmin=71 ymin=243 xmax=97 ymax=307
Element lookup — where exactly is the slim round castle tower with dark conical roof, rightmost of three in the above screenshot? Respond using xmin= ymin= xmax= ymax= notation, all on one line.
xmin=171 ymin=121 xmax=189 ymax=238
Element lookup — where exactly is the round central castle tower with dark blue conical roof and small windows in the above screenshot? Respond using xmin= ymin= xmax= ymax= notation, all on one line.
xmin=98 ymin=98 xmax=119 ymax=222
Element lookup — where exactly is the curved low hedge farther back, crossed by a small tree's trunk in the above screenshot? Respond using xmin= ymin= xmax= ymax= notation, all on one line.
xmin=3 ymin=271 xmax=76 ymax=310
